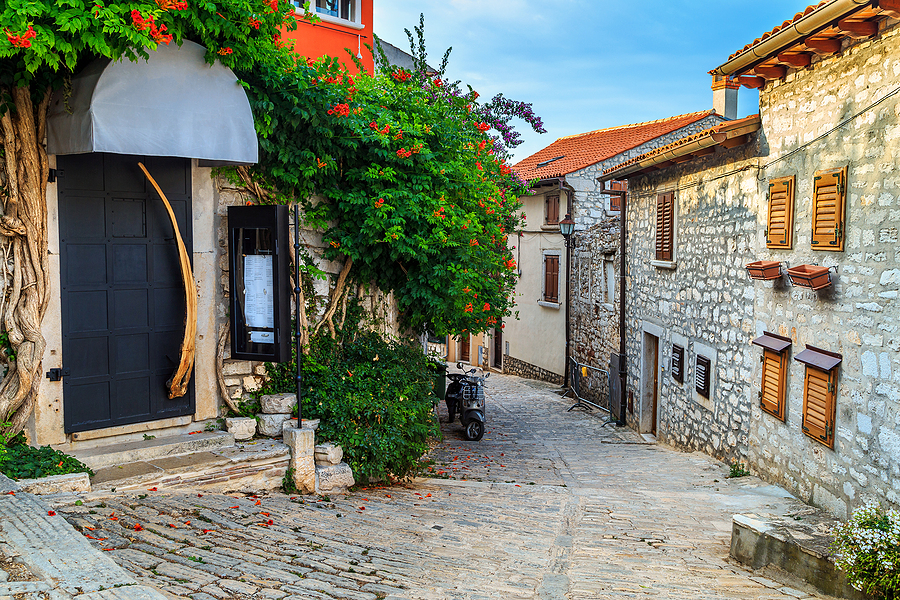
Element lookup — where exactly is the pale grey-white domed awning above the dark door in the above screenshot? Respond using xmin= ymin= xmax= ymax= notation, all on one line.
xmin=47 ymin=41 xmax=259 ymax=165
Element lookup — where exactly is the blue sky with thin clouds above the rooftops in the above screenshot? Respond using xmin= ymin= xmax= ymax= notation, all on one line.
xmin=374 ymin=0 xmax=810 ymax=160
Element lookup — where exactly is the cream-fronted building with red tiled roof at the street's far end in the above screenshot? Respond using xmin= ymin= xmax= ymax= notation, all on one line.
xmin=510 ymin=112 xmax=725 ymax=389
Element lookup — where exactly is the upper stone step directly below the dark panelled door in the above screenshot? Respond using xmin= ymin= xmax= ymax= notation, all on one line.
xmin=68 ymin=431 xmax=234 ymax=471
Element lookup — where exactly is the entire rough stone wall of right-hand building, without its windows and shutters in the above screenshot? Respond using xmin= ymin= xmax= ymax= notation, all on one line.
xmin=628 ymin=26 xmax=900 ymax=518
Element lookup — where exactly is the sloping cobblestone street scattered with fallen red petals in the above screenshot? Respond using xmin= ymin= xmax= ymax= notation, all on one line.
xmin=57 ymin=375 xmax=809 ymax=600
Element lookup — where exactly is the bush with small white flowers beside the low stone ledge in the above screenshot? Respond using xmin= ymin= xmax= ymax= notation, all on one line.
xmin=832 ymin=503 xmax=900 ymax=600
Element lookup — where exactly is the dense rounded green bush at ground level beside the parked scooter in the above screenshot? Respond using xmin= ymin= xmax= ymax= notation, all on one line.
xmin=262 ymin=318 xmax=439 ymax=482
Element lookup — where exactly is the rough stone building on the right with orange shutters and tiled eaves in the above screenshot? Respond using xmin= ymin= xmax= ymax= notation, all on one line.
xmin=602 ymin=0 xmax=900 ymax=517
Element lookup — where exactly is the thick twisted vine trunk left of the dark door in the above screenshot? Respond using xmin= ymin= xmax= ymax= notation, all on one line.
xmin=0 ymin=87 xmax=50 ymax=434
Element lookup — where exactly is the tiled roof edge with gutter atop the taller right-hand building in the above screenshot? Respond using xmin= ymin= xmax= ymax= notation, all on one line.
xmin=710 ymin=0 xmax=872 ymax=76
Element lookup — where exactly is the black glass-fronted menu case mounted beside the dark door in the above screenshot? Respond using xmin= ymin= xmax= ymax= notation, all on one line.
xmin=228 ymin=206 xmax=291 ymax=362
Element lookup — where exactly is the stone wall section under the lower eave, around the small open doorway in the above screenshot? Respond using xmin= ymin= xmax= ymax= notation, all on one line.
xmin=626 ymin=142 xmax=762 ymax=462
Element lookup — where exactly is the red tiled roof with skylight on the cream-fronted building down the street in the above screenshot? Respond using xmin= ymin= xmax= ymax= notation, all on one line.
xmin=513 ymin=110 xmax=716 ymax=181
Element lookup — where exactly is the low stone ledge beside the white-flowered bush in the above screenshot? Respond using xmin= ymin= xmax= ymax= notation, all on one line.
xmin=731 ymin=508 xmax=869 ymax=600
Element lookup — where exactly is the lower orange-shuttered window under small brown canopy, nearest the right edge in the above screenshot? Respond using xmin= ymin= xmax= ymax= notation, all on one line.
xmin=796 ymin=345 xmax=843 ymax=448
